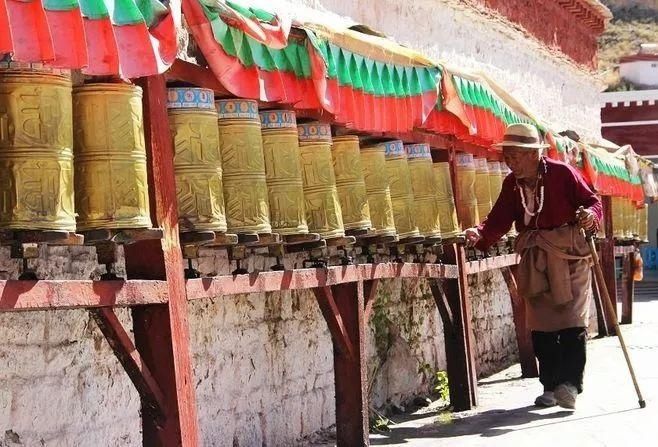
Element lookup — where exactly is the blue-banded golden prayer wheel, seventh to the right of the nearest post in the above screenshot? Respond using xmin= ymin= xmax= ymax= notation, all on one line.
xmin=384 ymin=140 xmax=420 ymax=238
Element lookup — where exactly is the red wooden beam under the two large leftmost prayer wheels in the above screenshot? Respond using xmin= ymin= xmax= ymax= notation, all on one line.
xmin=0 ymin=280 xmax=167 ymax=311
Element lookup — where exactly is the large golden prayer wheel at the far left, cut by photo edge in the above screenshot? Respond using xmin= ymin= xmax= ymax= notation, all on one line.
xmin=0 ymin=63 xmax=75 ymax=231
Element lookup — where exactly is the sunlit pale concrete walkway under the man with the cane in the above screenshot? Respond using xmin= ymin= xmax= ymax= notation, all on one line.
xmin=370 ymin=282 xmax=658 ymax=447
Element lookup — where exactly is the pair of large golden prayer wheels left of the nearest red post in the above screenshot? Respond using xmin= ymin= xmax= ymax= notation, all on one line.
xmin=0 ymin=69 xmax=151 ymax=231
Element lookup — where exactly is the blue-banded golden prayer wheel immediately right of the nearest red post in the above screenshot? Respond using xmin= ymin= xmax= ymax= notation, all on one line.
xmin=167 ymin=87 xmax=226 ymax=232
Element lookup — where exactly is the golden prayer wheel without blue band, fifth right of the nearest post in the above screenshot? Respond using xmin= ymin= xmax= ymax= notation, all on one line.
xmin=331 ymin=135 xmax=372 ymax=230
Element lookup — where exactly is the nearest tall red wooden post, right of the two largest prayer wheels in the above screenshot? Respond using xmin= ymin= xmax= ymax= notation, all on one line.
xmin=125 ymin=76 xmax=198 ymax=447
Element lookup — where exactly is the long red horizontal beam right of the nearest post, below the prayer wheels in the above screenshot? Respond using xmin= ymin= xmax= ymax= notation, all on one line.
xmin=187 ymin=263 xmax=457 ymax=300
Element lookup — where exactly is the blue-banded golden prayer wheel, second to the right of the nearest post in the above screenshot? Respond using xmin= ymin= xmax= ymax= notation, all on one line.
xmin=215 ymin=99 xmax=272 ymax=234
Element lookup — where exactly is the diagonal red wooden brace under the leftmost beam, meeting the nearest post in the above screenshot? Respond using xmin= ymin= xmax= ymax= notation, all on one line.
xmin=89 ymin=307 xmax=166 ymax=425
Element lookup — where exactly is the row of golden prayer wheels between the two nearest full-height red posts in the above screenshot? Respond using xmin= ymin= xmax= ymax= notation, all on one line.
xmin=168 ymin=88 xmax=460 ymax=242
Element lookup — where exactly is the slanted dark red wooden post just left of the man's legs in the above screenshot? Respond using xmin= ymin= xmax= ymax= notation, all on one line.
xmin=501 ymin=266 xmax=539 ymax=377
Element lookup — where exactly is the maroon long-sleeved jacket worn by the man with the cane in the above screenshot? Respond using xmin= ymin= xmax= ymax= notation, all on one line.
xmin=476 ymin=157 xmax=603 ymax=250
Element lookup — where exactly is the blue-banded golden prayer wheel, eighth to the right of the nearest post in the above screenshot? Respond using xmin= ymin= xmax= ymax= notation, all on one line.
xmin=404 ymin=144 xmax=441 ymax=237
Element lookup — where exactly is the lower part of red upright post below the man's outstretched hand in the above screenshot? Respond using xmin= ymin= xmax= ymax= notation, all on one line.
xmin=432 ymin=244 xmax=477 ymax=411
